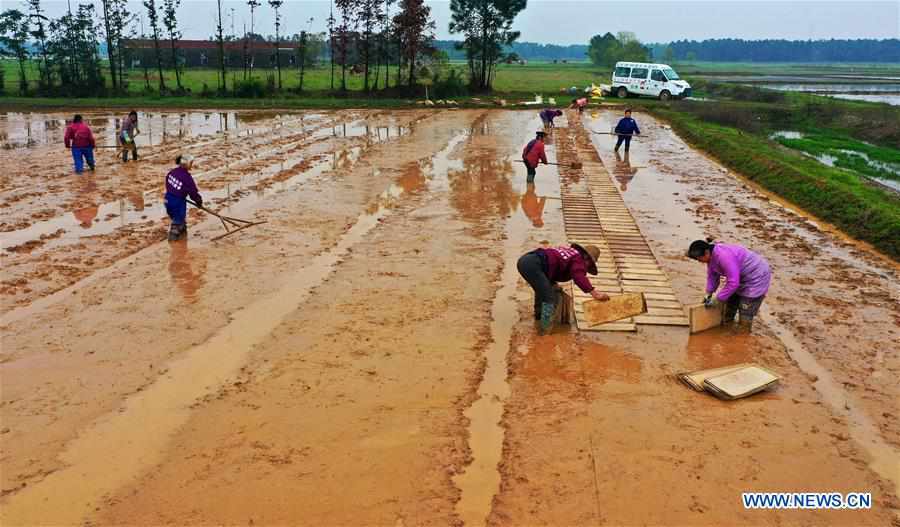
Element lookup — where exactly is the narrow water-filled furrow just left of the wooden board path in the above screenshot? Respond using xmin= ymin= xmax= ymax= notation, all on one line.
xmin=453 ymin=115 xmax=544 ymax=527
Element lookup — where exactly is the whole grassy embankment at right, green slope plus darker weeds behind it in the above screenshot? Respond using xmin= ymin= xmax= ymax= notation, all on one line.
xmin=647 ymin=85 xmax=900 ymax=261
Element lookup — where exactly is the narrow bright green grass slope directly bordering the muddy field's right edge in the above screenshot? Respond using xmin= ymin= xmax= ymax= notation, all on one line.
xmin=650 ymin=105 xmax=900 ymax=261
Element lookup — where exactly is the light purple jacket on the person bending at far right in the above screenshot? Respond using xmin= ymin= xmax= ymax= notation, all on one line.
xmin=706 ymin=243 xmax=772 ymax=302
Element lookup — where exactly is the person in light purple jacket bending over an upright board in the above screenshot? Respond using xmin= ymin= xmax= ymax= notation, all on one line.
xmin=688 ymin=238 xmax=772 ymax=332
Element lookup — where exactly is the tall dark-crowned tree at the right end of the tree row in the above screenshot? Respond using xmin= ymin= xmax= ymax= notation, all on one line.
xmin=450 ymin=0 xmax=527 ymax=91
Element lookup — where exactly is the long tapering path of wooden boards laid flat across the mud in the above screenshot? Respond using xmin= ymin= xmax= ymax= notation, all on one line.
xmin=554 ymin=113 xmax=689 ymax=331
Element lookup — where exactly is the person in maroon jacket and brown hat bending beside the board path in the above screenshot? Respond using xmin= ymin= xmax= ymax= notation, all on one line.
xmin=516 ymin=243 xmax=609 ymax=335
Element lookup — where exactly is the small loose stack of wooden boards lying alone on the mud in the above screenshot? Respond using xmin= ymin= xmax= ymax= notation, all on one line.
xmin=676 ymin=364 xmax=780 ymax=401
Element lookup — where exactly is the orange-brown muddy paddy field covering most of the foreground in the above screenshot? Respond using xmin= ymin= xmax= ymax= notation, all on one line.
xmin=0 ymin=109 xmax=900 ymax=526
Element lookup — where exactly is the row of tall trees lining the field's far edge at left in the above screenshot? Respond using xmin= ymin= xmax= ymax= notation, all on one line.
xmin=0 ymin=0 xmax=527 ymax=95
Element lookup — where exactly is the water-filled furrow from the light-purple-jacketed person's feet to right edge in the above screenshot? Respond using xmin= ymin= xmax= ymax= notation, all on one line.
xmin=760 ymin=308 xmax=900 ymax=498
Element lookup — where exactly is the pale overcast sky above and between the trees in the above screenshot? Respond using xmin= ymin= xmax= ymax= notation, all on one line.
xmin=14 ymin=0 xmax=900 ymax=44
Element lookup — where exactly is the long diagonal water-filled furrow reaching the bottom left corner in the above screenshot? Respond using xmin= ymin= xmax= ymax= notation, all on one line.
xmin=0 ymin=156 xmax=414 ymax=525
